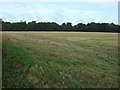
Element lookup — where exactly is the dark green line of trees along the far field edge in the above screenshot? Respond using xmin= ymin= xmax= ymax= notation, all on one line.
xmin=2 ymin=21 xmax=120 ymax=32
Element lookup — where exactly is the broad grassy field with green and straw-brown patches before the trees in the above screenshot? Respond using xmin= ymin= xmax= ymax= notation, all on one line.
xmin=2 ymin=32 xmax=118 ymax=88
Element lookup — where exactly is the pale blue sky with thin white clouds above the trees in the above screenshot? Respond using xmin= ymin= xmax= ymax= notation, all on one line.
xmin=0 ymin=0 xmax=118 ymax=25
